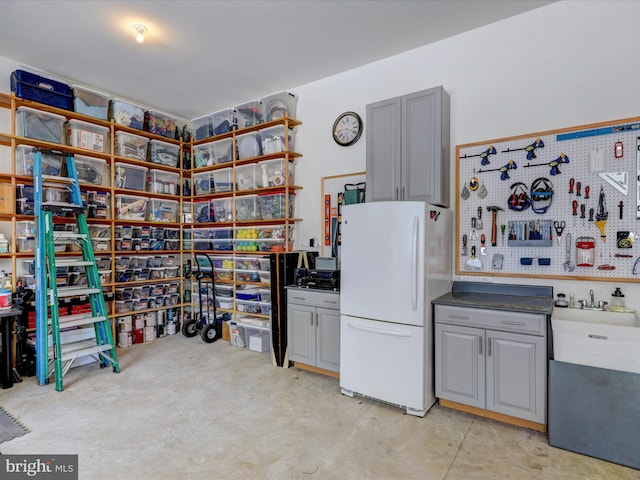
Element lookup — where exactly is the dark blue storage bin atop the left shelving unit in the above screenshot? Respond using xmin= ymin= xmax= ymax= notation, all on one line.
xmin=11 ymin=70 xmax=71 ymax=110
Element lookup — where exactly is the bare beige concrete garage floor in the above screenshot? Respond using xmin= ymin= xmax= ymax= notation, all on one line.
xmin=0 ymin=335 xmax=640 ymax=480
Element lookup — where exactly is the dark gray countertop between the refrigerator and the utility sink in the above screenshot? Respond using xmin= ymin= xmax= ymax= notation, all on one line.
xmin=432 ymin=282 xmax=553 ymax=315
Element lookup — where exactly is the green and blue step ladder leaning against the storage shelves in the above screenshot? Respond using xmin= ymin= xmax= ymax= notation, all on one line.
xmin=33 ymin=148 xmax=120 ymax=392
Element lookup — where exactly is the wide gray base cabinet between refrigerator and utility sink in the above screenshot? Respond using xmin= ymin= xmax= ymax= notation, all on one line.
xmin=435 ymin=305 xmax=547 ymax=424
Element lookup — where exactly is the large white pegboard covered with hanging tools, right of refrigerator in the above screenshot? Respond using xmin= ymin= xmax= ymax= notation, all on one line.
xmin=455 ymin=117 xmax=640 ymax=281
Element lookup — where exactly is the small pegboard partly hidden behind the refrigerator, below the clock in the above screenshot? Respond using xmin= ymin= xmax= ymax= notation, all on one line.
xmin=320 ymin=172 xmax=366 ymax=257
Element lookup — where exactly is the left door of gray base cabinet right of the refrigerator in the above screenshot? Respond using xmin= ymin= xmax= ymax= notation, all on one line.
xmin=435 ymin=323 xmax=485 ymax=408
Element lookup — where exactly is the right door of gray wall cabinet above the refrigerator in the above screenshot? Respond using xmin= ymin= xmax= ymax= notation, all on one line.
xmin=401 ymin=87 xmax=449 ymax=204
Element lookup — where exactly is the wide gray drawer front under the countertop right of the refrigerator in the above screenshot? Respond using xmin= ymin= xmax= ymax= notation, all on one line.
xmin=435 ymin=305 xmax=546 ymax=335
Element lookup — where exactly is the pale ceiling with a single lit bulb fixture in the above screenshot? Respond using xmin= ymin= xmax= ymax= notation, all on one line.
xmin=0 ymin=0 xmax=555 ymax=119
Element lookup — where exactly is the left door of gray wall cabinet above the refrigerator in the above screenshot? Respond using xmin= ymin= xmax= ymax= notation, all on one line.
xmin=365 ymin=97 xmax=402 ymax=202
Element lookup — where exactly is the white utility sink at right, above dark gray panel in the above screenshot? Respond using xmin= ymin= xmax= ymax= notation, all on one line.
xmin=551 ymin=308 xmax=640 ymax=373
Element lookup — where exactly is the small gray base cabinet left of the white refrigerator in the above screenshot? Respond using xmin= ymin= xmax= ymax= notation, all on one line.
xmin=287 ymin=288 xmax=340 ymax=372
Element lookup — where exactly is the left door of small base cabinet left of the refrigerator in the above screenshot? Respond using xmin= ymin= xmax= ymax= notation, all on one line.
xmin=287 ymin=303 xmax=316 ymax=365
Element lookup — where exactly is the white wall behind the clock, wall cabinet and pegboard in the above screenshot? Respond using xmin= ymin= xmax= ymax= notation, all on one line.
xmin=293 ymin=0 xmax=640 ymax=309
